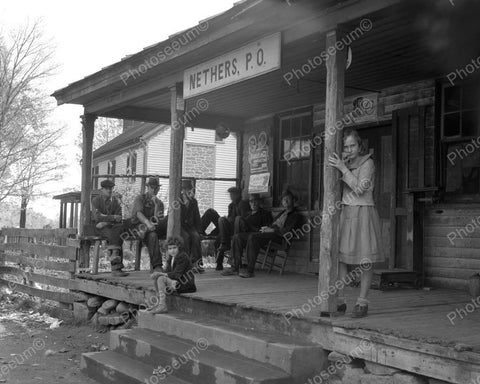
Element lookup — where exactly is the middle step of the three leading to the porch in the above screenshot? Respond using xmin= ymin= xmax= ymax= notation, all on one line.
xmin=110 ymin=328 xmax=295 ymax=384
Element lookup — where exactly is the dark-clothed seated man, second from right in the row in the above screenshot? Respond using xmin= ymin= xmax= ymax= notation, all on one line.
xmin=222 ymin=193 xmax=272 ymax=276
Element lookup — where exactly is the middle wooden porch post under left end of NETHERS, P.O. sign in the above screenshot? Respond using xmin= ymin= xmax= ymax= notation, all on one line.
xmin=167 ymin=83 xmax=185 ymax=237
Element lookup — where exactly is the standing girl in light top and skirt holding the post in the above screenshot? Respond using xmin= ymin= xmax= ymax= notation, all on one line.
xmin=328 ymin=130 xmax=384 ymax=317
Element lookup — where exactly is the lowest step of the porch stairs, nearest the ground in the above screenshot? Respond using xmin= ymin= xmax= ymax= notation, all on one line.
xmin=80 ymin=351 xmax=189 ymax=384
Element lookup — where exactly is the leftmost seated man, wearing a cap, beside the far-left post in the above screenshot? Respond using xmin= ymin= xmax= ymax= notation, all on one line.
xmin=92 ymin=180 xmax=128 ymax=277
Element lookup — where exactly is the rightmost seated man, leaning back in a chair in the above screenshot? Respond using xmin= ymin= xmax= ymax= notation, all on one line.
xmin=239 ymin=191 xmax=303 ymax=278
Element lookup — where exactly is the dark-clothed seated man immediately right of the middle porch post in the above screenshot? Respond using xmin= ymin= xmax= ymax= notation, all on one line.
xmin=180 ymin=180 xmax=204 ymax=273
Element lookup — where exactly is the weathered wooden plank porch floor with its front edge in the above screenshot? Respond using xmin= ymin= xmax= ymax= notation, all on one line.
xmin=77 ymin=270 xmax=480 ymax=384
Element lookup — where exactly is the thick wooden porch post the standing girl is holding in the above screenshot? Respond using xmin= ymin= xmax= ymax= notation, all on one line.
xmin=318 ymin=30 xmax=346 ymax=314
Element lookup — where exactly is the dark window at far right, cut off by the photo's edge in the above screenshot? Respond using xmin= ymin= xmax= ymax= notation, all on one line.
xmin=441 ymin=84 xmax=480 ymax=200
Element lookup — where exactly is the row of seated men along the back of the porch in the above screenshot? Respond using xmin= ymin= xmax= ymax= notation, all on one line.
xmin=92 ymin=178 xmax=302 ymax=278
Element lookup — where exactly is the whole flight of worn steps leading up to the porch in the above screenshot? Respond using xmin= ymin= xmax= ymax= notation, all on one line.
xmin=81 ymin=312 xmax=326 ymax=384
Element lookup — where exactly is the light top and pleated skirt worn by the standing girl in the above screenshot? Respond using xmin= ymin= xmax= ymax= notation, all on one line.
xmin=339 ymin=155 xmax=385 ymax=264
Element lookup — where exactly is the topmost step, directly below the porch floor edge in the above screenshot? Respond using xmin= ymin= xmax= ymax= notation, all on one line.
xmin=138 ymin=312 xmax=327 ymax=377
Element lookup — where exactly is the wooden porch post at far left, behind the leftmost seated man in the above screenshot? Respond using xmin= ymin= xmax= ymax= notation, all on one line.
xmin=79 ymin=114 xmax=97 ymax=235
